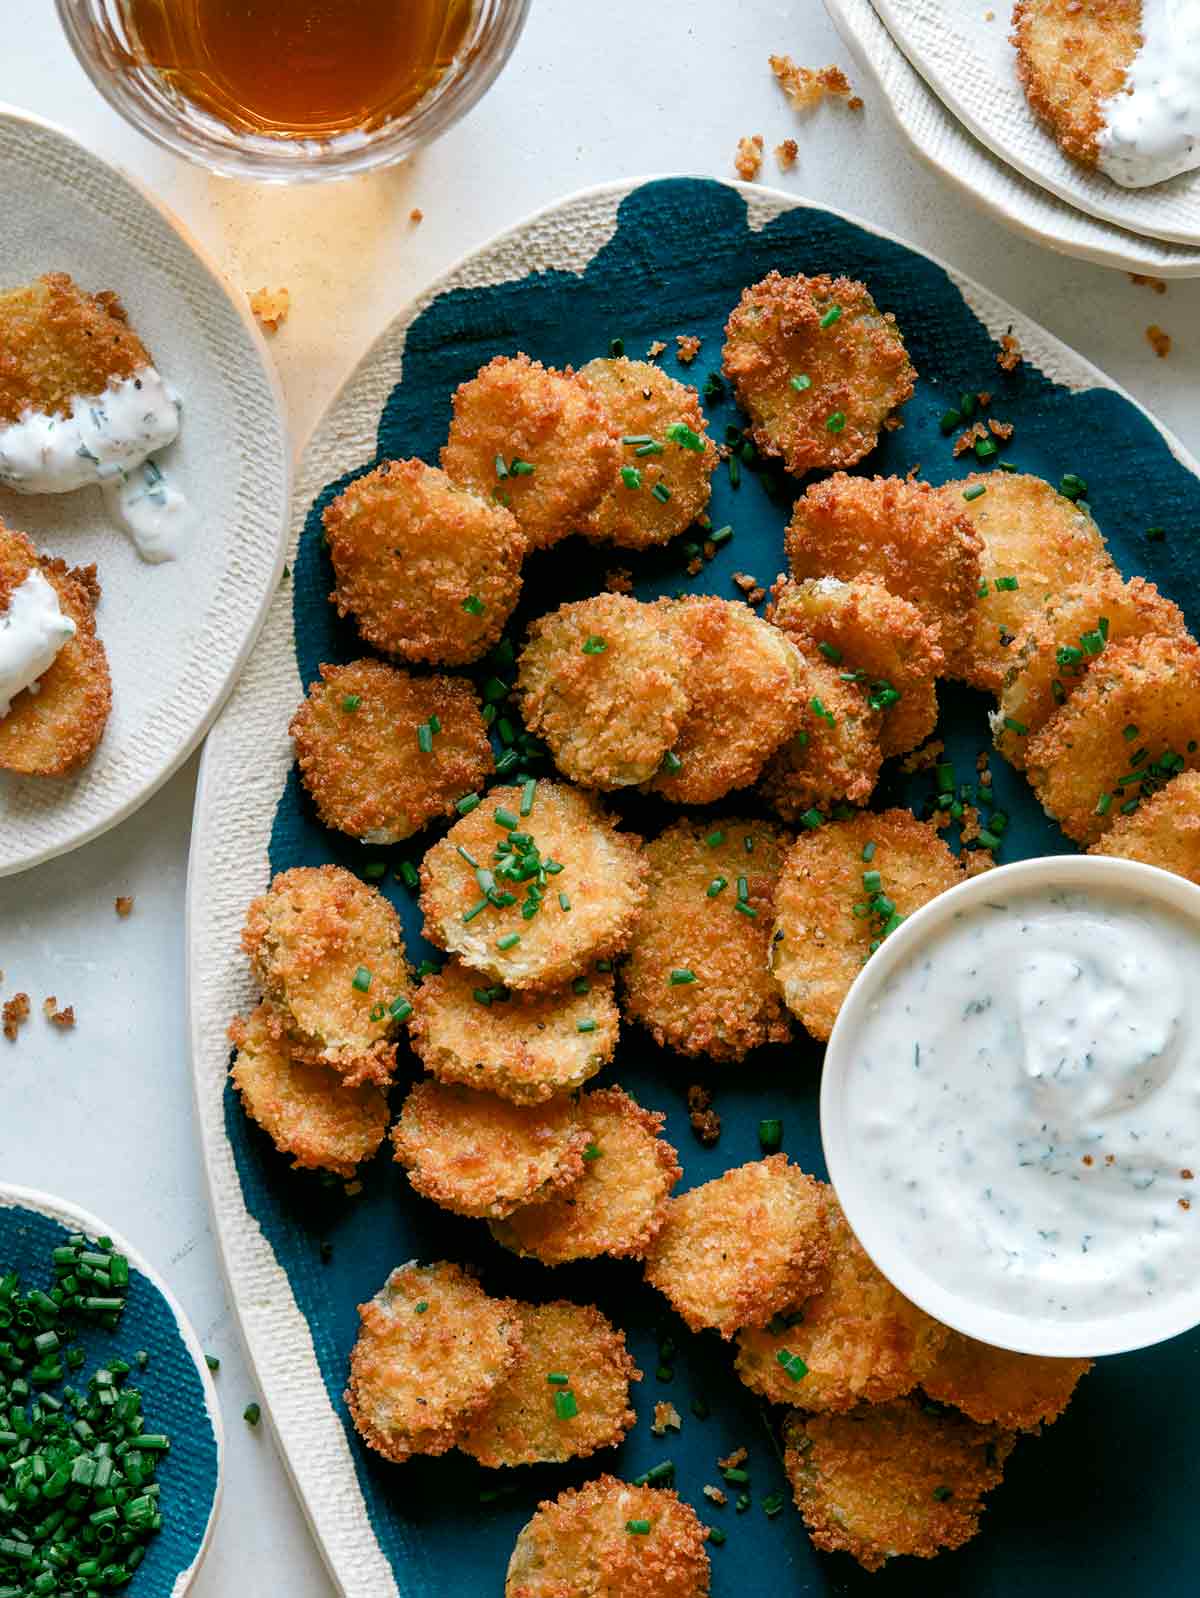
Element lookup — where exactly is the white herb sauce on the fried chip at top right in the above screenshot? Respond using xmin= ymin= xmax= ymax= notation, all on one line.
xmin=1098 ymin=0 xmax=1200 ymax=189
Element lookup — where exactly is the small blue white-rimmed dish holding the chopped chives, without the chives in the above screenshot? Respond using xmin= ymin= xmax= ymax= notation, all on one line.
xmin=0 ymin=1186 xmax=222 ymax=1598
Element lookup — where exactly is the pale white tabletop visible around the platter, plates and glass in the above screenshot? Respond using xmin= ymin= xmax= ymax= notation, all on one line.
xmin=0 ymin=0 xmax=1200 ymax=1598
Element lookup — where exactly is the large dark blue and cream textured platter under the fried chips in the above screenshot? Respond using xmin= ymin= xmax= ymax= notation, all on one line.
xmin=189 ymin=179 xmax=1200 ymax=1598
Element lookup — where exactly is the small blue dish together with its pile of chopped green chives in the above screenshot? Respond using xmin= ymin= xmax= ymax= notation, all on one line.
xmin=0 ymin=1186 xmax=222 ymax=1598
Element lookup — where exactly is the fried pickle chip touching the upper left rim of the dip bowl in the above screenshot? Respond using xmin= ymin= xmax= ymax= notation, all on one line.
xmin=770 ymin=810 xmax=965 ymax=1042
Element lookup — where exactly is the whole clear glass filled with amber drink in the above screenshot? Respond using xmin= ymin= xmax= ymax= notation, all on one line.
xmin=56 ymin=0 xmax=529 ymax=182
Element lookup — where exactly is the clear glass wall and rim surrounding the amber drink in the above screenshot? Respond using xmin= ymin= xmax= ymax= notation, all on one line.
xmin=54 ymin=0 xmax=529 ymax=182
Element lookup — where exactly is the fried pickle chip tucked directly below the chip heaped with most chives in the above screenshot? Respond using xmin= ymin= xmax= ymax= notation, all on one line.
xmin=409 ymin=960 xmax=620 ymax=1104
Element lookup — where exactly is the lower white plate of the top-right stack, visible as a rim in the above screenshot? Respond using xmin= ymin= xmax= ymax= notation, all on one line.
xmin=825 ymin=0 xmax=1200 ymax=278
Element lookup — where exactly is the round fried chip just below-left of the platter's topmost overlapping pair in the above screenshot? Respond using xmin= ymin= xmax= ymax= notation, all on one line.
xmin=324 ymin=460 xmax=526 ymax=666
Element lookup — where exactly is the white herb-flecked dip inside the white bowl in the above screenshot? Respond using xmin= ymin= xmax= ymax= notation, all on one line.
xmin=847 ymin=890 xmax=1200 ymax=1320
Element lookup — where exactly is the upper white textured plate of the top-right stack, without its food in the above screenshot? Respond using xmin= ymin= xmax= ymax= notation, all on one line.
xmin=872 ymin=0 xmax=1200 ymax=246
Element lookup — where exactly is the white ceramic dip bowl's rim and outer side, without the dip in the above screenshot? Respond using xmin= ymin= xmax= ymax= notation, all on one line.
xmin=821 ymin=855 xmax=1200 ymax=1358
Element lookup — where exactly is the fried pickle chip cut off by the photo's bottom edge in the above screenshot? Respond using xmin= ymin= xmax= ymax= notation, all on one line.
xmin=505 ymin=1475 xmax=709 ymax=1598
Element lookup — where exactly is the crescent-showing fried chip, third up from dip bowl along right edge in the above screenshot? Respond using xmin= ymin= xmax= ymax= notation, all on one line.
xmin=991 ymin=567 xmax=1187 ymax=770
